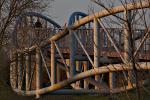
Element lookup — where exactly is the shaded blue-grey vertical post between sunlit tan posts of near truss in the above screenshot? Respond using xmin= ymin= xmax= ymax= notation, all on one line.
xmin=70 ymin=30 xmax=76 ymax=77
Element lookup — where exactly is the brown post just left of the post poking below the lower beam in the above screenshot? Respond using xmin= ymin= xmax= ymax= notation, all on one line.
xmin=25 ymin=53 xmax=31 ymax=91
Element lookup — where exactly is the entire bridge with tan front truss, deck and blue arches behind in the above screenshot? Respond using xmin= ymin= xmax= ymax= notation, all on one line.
xmin=10 ymin=1 xmax=150 ymax=98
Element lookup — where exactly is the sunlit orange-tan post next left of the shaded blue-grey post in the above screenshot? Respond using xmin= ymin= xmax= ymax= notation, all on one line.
xmin=51 ymin=41 xmax=57 ymax=85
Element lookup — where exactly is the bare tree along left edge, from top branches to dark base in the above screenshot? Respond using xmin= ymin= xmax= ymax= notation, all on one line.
xmin=0 ymin=0 xmax=53 ymax=98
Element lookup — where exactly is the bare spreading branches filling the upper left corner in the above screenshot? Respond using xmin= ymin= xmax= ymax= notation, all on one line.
xmin=0 ymin=0 xmax=53 ymax=47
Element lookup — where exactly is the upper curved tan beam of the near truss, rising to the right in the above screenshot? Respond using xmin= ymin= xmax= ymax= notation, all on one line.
xmin=26 ymin=1 xmax=150 ymax=51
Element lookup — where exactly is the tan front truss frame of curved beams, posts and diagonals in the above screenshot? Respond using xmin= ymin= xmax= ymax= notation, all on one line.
xmin=10 ymin=1 xmax=150 ymax=98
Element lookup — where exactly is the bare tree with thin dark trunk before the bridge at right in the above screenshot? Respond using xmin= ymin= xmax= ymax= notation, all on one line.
xmin=91 ymin=0 xmax=150 ymax=100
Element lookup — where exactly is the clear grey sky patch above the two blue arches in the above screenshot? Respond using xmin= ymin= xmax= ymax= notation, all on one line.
xmin=48 ymin=0 xmax=99 ymax=26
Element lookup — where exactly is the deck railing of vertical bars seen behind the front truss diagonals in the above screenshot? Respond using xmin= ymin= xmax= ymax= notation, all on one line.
xmin=58 ymin=28 xmax=150 ymax=54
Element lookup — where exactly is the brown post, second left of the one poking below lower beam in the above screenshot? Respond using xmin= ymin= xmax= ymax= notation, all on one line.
xmin=18 ymin=52 xmax=22 ymax=91
